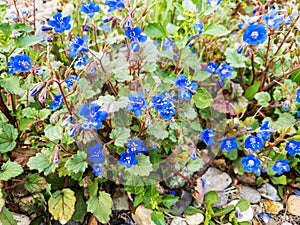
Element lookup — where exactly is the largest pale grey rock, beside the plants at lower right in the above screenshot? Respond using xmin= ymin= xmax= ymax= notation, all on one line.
xmin=202 ymin=167 xmax=232 ymax=193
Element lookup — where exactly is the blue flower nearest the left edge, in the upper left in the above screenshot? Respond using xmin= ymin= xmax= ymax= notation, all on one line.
xmin=7 ymin=54 xmax=32 ymax=74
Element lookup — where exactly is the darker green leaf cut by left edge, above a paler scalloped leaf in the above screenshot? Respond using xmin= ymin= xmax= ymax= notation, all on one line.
xmin=0 ymin=122 xmax=18 ymax=153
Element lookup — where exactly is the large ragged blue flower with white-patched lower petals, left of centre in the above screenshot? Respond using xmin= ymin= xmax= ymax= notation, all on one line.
xmin=79 ymin=103 xmax=108 ymax=130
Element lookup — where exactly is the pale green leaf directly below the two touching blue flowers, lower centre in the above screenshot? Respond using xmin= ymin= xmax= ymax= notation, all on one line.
xmin=128 ymin=155 xmax=153 ymax=176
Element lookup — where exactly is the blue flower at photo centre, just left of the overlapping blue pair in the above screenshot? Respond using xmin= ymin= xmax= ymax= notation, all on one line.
xmin=126 ymin=92 xmax=148 ymax=116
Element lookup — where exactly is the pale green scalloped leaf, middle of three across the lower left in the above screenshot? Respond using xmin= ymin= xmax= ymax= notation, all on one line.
xmin=27 ymin=149 xmax=58 ymax=176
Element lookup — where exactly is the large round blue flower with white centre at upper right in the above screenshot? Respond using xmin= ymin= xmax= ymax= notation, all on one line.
xmin=243 ymin=24 xmax=268 ymax=45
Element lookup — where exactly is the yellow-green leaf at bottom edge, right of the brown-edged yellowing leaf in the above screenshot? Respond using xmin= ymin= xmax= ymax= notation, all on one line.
xmin=87 ymin=191 xmax=112 ymax=223
